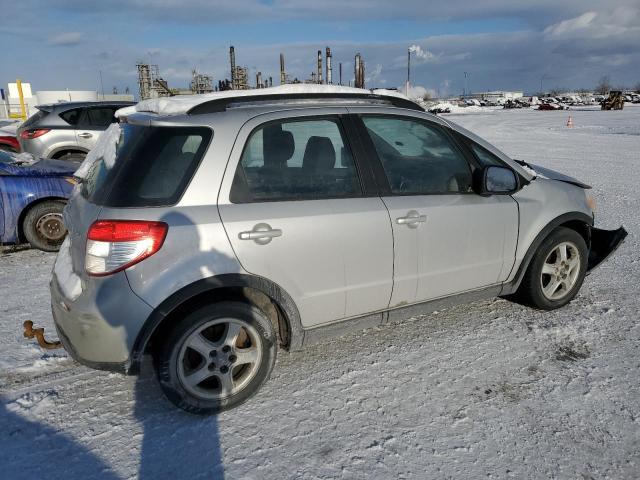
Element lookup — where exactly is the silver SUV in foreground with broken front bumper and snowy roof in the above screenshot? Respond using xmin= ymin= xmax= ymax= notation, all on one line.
xmin=51 ymin=89 xmax=626 ymax=413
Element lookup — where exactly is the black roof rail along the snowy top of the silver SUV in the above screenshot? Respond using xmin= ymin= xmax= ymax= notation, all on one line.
xmin=187 ymin=93 xmax=424 ymax=115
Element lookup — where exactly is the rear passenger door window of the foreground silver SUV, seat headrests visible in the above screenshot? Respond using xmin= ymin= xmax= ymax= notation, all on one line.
xmin=230 ymin=118 xmax=362 ymax=203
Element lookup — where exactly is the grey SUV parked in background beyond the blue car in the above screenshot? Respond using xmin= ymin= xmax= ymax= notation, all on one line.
xmin=17 ymin=102 xmax=133 ymax=162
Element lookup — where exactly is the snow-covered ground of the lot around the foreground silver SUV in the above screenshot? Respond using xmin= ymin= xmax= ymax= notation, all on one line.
xmin=0 ymin=106 xmax=640 ymax=479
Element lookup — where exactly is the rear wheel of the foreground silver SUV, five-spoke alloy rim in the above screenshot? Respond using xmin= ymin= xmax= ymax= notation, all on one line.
xmin=157 ymin=302 xmax=277 ymax=415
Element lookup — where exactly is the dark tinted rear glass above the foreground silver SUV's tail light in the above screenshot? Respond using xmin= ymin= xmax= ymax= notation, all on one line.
xmin=82 ymin=124 xmax=212 ymax=207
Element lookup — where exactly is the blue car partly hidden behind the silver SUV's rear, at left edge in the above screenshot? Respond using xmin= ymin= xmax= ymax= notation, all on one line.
xmin=0 ymin=151 xmax=79 ymax=252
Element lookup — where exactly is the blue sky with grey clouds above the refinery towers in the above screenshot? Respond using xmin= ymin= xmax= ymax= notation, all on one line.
xmin=0 ymin=0 xmax=640 ymax=96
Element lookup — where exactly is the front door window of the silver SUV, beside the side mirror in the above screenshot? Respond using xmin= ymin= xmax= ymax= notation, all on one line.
xmin=362 ymin=116 xmax=471 ymax=195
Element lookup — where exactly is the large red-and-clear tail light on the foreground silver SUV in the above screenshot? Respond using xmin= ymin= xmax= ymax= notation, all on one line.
xmin=85 ymin=220 xmax=169 ymax=277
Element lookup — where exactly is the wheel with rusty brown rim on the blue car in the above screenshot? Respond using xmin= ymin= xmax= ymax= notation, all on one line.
xmin=22 ymin=200 xmax=67 ymax=252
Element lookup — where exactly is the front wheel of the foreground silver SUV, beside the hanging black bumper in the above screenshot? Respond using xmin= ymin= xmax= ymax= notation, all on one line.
xmin=516 ymin=227 xmax=589 ymax=310
